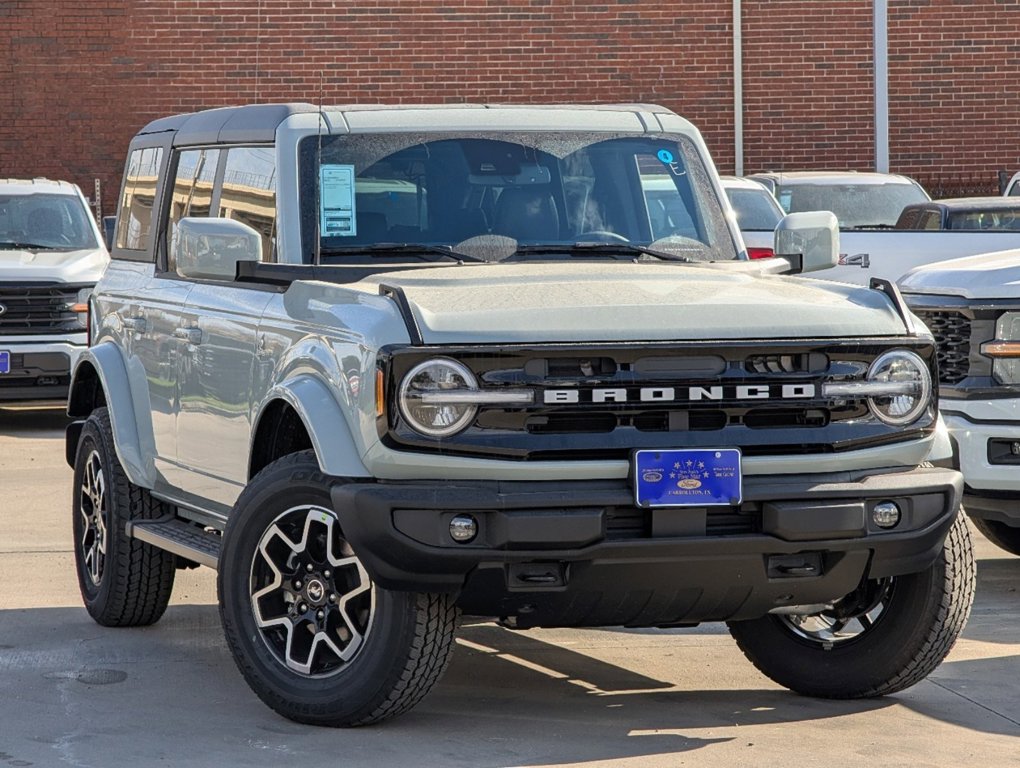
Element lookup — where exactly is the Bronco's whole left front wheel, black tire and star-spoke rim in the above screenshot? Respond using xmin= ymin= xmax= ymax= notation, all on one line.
xmin=217 ymin=451 xmax=457 ymax=726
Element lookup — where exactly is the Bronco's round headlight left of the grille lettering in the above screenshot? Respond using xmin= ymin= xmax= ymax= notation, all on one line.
xmin=399 ymin=358 xmax=478 ymax=438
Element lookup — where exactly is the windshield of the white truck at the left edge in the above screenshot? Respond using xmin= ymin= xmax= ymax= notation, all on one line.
xmin=0 ymin=193 xmax=97 ymax=251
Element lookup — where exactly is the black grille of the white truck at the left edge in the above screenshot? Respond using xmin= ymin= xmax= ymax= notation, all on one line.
xmin=0 ymin=283 xmax=87 ymax=336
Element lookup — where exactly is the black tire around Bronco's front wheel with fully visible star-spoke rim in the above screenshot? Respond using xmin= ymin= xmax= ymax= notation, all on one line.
xmin=217 ymin=451 xmax=458 ymax=727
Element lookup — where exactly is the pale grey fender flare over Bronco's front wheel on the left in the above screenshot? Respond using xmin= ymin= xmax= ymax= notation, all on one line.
xmin=255 ymin=373 xmax=371 ymax=477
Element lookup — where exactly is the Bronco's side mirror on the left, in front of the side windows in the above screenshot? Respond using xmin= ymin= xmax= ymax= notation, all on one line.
xmin=170 ymin=216 xmax=262 ymax=279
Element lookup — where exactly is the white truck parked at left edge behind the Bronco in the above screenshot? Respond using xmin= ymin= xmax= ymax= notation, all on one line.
xmin=0 ymin=178 xmax=109 ymax=402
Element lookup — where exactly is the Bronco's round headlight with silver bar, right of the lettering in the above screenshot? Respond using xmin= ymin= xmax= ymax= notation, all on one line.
xmin=822 ymin=350 xmax=931 ymax=426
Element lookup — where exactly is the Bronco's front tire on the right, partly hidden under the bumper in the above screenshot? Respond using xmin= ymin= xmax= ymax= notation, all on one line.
xmin=729 ymin=515 xmax=976 ymax=699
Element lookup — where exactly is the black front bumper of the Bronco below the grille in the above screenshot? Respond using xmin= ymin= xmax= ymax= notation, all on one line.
xmin=333 ymin=467 xmax=963 ymax=626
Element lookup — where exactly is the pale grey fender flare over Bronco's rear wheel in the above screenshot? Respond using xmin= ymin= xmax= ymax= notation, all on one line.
xmin=67 ymin=342 xmax=156 ymax=489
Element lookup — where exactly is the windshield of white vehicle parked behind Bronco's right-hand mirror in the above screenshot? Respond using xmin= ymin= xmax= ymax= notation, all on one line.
xmin=776 ymin=183 xmax=928 ymax=229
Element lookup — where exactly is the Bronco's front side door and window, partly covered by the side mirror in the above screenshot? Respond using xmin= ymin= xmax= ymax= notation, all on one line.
xmin=177 ymin=146 xmax=276 ymax=513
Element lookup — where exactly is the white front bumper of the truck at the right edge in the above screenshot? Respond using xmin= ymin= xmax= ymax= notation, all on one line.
xmin=942 ymin=398 xmax=1020 ymax=526
